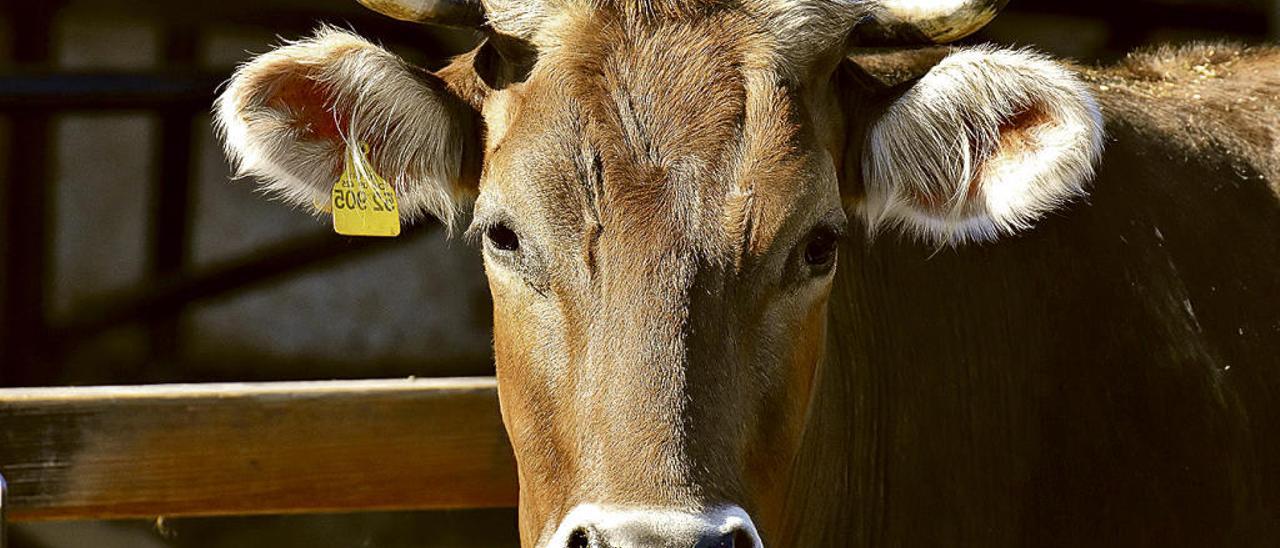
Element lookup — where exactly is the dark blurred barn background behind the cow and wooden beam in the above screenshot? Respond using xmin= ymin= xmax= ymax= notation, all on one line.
xmin=0 ymin=0 xmax=1280 ymax=548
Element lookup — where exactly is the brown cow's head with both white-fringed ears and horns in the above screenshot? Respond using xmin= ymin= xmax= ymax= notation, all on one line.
xmin=218 ymin=0 xmax=1100 ymax=548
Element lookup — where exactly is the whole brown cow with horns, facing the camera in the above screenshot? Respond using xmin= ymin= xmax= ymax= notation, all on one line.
xmin=215 ymin=0 xmax=1280 ymax=548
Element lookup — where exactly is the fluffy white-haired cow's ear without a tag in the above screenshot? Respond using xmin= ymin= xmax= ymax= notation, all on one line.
xmin=851 ymin=47 xmax=1102 ymax=245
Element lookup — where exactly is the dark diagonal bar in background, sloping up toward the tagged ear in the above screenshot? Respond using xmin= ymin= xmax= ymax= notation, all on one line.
xmin=52 ymin=223 xmax=435 ymax=342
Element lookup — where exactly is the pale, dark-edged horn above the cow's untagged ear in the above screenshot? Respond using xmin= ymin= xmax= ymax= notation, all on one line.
xmin=850 ymin=0 xmax=1009 ymax=47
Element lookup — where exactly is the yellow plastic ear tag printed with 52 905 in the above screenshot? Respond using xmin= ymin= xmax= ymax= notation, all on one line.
xmin=330 ymin=143 xmax=399 ymax=236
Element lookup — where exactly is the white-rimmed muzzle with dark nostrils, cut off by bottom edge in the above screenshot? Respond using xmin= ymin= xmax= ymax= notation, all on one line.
xmin=545 ymin=504 xmax=763 ymax=548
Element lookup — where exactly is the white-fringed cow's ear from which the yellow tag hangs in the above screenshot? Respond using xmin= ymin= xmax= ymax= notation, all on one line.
xmin=215 ymin=27 xmax=480 ymax=227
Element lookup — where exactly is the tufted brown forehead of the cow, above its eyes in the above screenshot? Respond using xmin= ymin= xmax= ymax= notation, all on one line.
xmin=486 ymin=12 xmax=833 ymax=263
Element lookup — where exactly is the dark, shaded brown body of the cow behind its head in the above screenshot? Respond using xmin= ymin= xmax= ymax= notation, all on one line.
xmin=790 ymin=46 xmax=1280 ymax=547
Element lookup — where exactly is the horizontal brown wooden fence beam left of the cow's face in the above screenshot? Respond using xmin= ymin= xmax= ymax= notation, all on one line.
xmin=0 ymin=378 xmax=516 ymax=521
